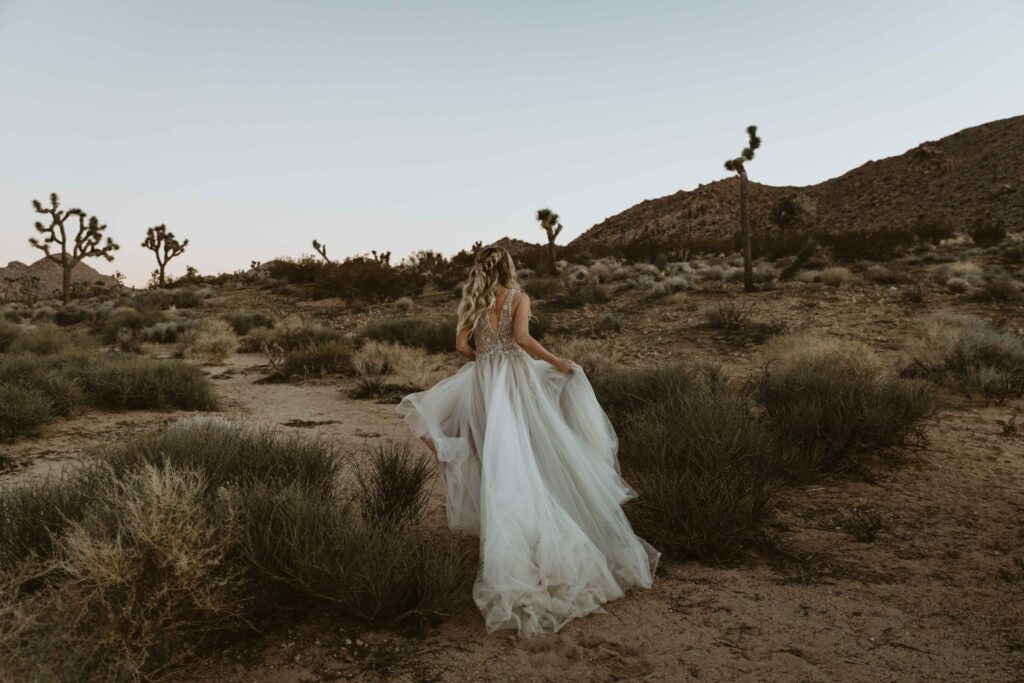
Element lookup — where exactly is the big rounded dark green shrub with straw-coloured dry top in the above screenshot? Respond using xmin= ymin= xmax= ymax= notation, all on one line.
xmin=754 ymin=337 xmax=937 ymax=478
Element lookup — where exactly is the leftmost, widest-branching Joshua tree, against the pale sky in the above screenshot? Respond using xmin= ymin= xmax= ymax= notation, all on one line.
xmin=29 ymin=193 xmax=120 ymax=305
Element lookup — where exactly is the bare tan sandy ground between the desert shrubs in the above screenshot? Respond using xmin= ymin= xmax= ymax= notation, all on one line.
xmin=0 ymin=280 xmax=1024 ymax=683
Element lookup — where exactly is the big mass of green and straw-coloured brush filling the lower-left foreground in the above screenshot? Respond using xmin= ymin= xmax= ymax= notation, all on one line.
xmin=0 ymin=420 xmax=475 ymax=680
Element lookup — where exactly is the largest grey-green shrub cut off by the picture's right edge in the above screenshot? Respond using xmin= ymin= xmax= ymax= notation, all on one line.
xmin=910 ymin=313 xmax=1024 ymax=401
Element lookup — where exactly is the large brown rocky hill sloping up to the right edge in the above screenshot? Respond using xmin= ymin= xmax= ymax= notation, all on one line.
xmin=571 ymin=116 xmax=1024 ymax=248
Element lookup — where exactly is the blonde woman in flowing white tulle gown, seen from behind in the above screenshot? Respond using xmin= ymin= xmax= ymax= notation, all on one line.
xmin=398 ymin=247 xmax=659 ymax=637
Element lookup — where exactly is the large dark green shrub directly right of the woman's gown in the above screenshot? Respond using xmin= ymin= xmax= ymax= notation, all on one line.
xmin=596 ymin=367 xmax=773 ymax=560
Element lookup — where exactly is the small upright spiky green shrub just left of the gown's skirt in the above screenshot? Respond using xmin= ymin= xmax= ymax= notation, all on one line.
xmin=356 ymin=441 xmax=434 ymax=525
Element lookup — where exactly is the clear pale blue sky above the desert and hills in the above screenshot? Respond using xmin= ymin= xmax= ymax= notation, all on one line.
xmin=0 ymin=0 xmax=1024 ymax=285
